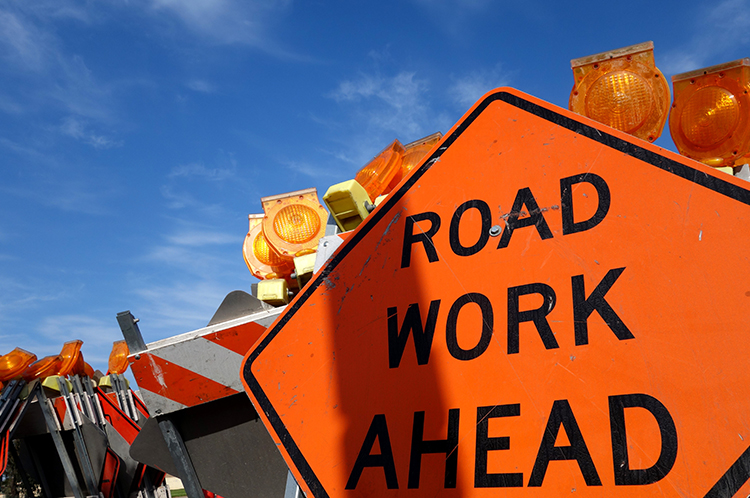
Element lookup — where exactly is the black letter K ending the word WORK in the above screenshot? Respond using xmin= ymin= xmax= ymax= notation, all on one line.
xmin=571 ymin=268 xmax=635 ymax=346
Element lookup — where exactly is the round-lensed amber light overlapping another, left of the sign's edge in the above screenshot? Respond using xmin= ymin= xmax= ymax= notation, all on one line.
xmin=260 ymin=188 xmax=328 ymax=260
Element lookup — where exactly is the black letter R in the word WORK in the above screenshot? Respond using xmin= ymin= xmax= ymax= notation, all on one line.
xmin=508 ymin=283 xmax=560 ymax=354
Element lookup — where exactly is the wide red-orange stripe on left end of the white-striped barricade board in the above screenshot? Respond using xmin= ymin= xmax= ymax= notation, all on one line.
xmin=130 ymin=353 xmax=239 ymax=406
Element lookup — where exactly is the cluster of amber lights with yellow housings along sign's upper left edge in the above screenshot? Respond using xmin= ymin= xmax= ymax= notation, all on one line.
xmin=243 ymin=133 xmax=442 ymax=305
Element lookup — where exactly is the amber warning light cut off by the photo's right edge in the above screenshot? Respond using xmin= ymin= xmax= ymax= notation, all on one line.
xmin=669 ymin=59 xmax=750 ymax=167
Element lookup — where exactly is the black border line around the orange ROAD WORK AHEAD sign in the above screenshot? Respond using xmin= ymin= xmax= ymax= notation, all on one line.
xmin=243 ymin=90 xmax=750 ymax=498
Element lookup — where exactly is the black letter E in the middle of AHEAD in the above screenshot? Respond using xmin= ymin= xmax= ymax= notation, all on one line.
xmin=474 ymin=403 xmax=523 ymax=488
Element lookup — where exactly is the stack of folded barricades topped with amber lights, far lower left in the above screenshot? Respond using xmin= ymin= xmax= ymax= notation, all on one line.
xmin=0 ymin=340 xmax=164 ymax=498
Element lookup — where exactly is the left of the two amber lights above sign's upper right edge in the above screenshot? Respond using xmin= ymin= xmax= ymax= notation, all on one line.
xmin=568 ymin=42 xmax=670 ymax=142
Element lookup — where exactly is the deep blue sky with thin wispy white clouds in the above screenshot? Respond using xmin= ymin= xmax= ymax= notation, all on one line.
xmin=0 ymin=0 xmax=750 ymax=370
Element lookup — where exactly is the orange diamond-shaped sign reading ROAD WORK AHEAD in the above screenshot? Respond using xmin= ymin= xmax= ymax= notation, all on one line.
xmin=243 ymin=89 xmax=750 ymax=498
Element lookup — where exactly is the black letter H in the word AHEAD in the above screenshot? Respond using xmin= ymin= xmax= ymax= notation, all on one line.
xmin=408 ymin=408 xmax=459 ymax=489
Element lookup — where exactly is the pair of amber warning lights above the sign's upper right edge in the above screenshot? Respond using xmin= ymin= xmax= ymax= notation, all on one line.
xmin=569 ymin=42 xmax=750 ymax=173
